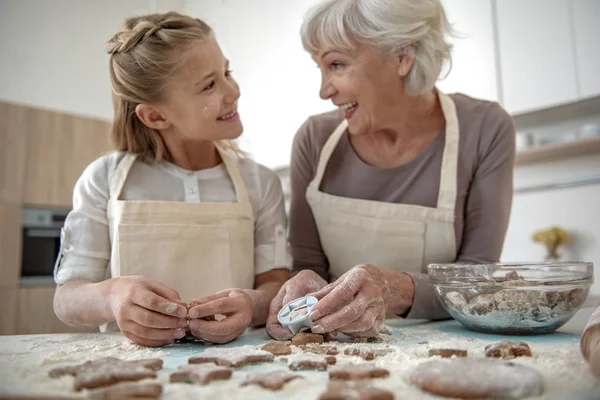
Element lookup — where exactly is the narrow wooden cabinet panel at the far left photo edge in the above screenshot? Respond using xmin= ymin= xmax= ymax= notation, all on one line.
xmin=0 ymin=101 xmax=28 ymax=203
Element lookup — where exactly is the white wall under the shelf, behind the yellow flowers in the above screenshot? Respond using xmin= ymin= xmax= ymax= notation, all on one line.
xmin=502 ymin=155 xmax=600 ymax=295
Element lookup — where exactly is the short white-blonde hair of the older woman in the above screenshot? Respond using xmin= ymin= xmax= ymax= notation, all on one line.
xmin=301 ymin=0 xmax=453 ymax=96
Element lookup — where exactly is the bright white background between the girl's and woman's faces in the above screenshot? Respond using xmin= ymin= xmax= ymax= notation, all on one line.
xmin=186 ymin=0 xmax=332 ymax=168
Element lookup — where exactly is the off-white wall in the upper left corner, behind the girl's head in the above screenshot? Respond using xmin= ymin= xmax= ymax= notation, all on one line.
xmin=0 ymin=0 xmax=181 ymax=120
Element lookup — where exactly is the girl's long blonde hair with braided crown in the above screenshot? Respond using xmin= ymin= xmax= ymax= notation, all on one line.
xmin=106 ymin=12 xmax=245 ymax=161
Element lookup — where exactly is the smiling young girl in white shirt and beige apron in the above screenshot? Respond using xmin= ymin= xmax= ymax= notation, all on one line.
xmin=54 ymin=12 xmax=291 ymax=346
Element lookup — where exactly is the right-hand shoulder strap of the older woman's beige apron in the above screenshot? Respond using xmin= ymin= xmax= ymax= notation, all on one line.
xmin=437 ymin=90 xmax=460 ymax=212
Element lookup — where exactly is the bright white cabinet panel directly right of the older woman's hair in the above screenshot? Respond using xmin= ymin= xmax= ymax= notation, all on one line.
xmin=437 ymin=0 xmax=500 ymax=101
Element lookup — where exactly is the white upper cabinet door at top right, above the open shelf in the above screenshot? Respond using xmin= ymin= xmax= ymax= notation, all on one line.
xmin=495 ymin=0 xmax=580 ymax=114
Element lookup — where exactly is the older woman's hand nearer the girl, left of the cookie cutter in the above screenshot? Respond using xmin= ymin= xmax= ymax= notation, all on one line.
xmin=267 ymin=270 xmax=327 ymax=340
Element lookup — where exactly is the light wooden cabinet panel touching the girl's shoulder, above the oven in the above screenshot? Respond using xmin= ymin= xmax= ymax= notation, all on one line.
xmin=23 ymin=105 xmax=110 ymax=208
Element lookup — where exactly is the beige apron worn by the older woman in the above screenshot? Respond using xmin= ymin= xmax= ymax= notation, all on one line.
xmin=306 ymin=91 xmax=459 ymax=282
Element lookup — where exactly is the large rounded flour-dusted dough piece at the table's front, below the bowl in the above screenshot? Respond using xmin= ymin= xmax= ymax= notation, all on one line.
xmin=410 ymin=358 xmax=544 ymax=399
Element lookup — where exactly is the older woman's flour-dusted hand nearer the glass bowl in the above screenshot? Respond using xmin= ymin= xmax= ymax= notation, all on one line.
xmin=310 ymin=264 xmax=390 ymax=337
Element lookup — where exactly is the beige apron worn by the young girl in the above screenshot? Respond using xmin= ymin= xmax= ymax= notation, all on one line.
xmin=101 ymin=149 xmax=254 ymax=330
